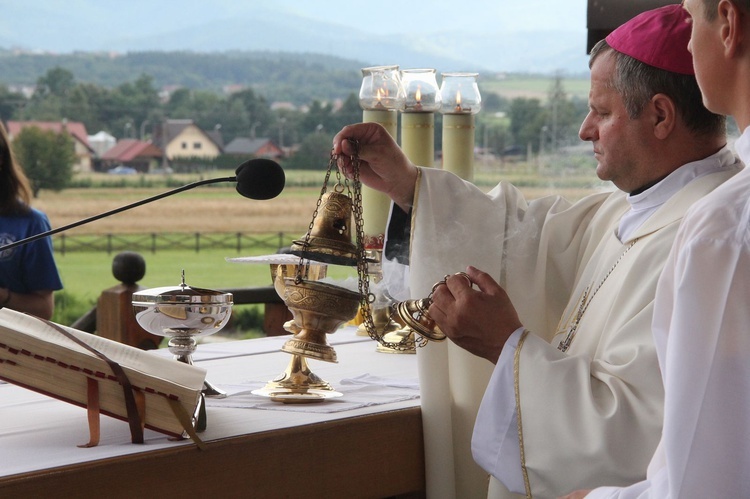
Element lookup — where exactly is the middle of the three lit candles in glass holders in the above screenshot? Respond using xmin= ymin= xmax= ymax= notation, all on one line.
xmin=401 ymin=69 xmax=441 ymax=166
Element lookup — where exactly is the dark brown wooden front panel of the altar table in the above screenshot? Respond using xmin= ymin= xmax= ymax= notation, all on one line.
xmin=0 ymin=408 xmax=425 ymax=499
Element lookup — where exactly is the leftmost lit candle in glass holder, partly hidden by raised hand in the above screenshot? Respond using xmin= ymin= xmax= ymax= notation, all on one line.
xmin=359 ymin=66 xmax=404 ymax=249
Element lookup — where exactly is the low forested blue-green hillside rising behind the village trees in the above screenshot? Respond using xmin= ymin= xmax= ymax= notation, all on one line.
xmin=0 ymin=49 xmax=588 ymax=105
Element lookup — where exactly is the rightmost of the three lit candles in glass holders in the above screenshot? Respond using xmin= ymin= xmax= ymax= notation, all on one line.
xmin=440 ymin=73 xmax=482 ymax=181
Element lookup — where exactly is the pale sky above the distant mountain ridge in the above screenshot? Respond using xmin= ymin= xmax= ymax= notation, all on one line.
xmin=0 ymin=0 xmax=592 ymax=49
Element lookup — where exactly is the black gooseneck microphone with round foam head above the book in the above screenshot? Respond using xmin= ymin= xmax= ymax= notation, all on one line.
xmin=0 ymin=158 xmax=286 ymax=252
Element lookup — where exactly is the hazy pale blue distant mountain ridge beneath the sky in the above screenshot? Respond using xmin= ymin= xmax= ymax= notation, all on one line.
xmin=101 ymin=18 xmax=588 ymax=73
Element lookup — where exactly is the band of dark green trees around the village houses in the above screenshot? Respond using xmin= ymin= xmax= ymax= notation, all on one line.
xmin=0 ymin=57 xmax=587 ymax=193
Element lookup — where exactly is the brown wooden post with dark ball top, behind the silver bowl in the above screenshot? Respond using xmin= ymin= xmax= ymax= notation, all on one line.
xmin=96 ymin=251 xmax=163 ymax=350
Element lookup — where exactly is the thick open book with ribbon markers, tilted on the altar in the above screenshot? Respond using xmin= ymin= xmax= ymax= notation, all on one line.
xmin=0 ymin=309 xmax=206 ymax=445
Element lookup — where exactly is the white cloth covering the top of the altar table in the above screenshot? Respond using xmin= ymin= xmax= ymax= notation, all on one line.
xmin=0 ymin=327 xmax=419 ymax=477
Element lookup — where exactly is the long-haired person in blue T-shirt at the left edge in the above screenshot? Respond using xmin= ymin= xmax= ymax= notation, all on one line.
xmin=0 ymin=123 xmax=62 ymax=319
